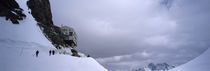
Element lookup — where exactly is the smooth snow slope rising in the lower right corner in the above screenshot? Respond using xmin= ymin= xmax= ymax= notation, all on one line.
xmin=170 ymin=49 xmax=210 ymax=71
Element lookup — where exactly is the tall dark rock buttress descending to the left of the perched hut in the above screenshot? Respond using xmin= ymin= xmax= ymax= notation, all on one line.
xmin=27 ymin=0 xmax=65 ymax=48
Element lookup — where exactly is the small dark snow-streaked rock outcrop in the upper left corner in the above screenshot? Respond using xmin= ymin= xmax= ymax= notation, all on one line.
xmin=0 ymin=0 xmax=26 ymax=24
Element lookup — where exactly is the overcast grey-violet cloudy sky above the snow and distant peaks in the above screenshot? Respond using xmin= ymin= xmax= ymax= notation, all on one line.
xmin=50 ymin=0 xmax=210 ymax=70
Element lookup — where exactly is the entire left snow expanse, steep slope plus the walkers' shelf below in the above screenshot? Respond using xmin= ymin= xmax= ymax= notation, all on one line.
xmin=0 ymin=0 xmax=107 ymax=71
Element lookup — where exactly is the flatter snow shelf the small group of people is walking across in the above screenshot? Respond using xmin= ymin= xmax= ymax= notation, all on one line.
xmin=0 ymin=39 xmax=107 ymax=71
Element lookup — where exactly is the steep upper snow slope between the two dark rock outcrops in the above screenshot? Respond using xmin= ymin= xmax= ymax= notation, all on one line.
xmin=0 ymin=0 xmax=52 ymax=47
